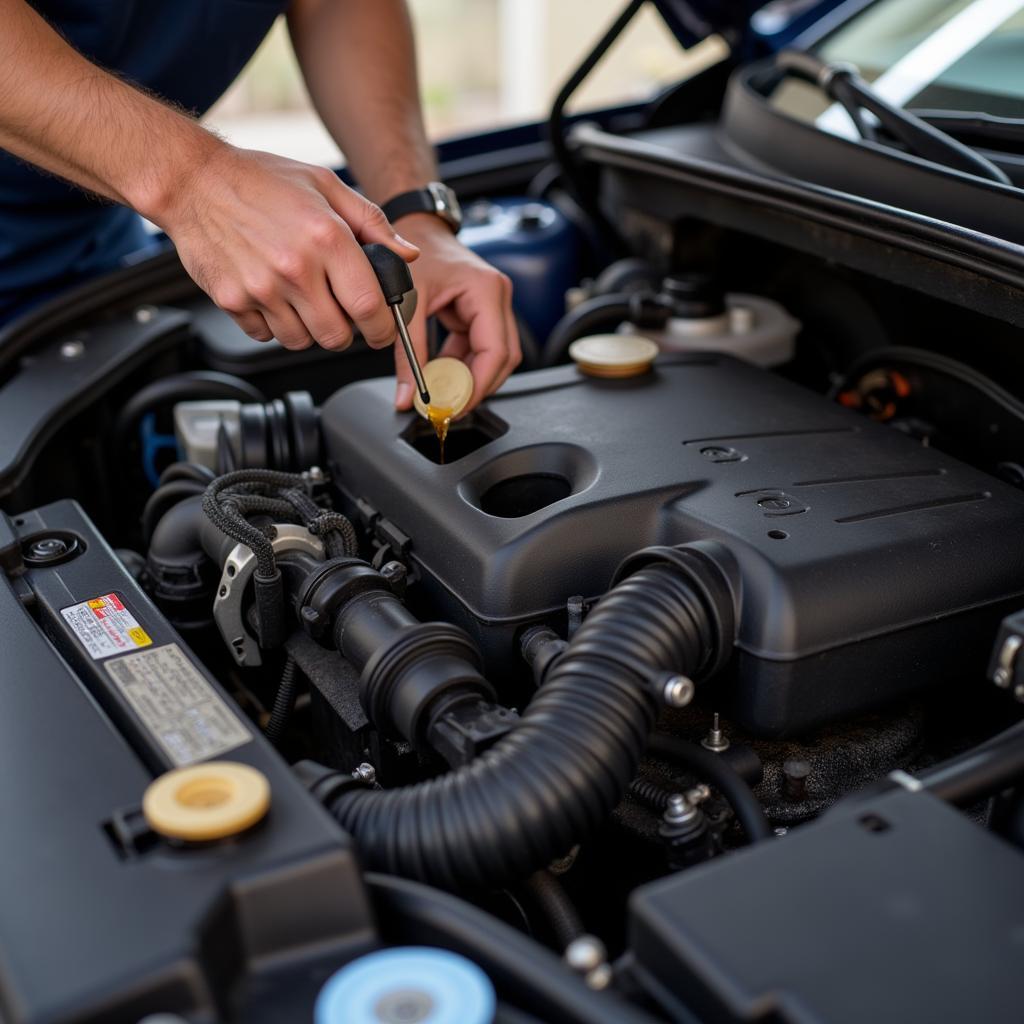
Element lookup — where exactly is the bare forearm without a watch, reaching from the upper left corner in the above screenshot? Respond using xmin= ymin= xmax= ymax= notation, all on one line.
xmin=0 ymin=0 xmax=222 ymax=221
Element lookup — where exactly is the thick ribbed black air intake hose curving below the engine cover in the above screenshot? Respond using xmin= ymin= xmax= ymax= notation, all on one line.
xmin=321 ymin=548 xmax=734 ymax=889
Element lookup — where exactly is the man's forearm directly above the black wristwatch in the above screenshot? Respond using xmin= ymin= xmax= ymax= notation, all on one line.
xmin=289 ymin=0 xmax=437 ymax=203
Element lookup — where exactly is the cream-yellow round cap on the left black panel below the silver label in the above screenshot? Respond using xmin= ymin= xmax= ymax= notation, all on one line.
xmin=142 ymin=761 xmax=270 ymax=843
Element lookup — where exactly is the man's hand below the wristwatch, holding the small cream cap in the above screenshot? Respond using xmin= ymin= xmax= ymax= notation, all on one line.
xmin=394 ymin=214 xmax=522 ymax=412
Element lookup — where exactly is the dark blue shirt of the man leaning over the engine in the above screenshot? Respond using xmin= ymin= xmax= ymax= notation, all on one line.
xmin=0 ymin=0 xmax=288 ymax=323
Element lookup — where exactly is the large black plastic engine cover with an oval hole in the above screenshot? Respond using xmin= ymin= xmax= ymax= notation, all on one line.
xmin=323 ymin=355 xmax=1024 ymax=734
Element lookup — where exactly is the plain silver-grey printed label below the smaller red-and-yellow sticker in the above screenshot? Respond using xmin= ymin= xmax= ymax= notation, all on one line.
xmin=106 ymin=643 xmax=251 ymax=768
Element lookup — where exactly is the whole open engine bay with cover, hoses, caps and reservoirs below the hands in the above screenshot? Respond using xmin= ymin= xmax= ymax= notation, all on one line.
xmin=0 ymin=140 xmax=1024 ymax=1024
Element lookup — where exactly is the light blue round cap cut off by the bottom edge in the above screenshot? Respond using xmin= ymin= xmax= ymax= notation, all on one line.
xmin=315 ymin=946 xmax=495 ymax=1024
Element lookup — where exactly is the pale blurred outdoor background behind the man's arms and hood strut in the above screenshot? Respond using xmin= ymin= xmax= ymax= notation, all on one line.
xmin=206 ymin=0 xmax=724 ymax=165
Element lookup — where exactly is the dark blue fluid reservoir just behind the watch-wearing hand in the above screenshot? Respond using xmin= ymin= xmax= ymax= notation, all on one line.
xmin=459 ymin=199 xmax=580 ymax=345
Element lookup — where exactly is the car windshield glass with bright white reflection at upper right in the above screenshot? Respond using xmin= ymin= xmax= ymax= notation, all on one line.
xmin=773 ymin=0 xmax=1024 ymax=137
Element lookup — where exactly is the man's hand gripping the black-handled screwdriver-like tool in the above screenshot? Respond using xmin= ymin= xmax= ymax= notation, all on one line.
xmin=153 ymin=145 xmax=418 ymax=350
